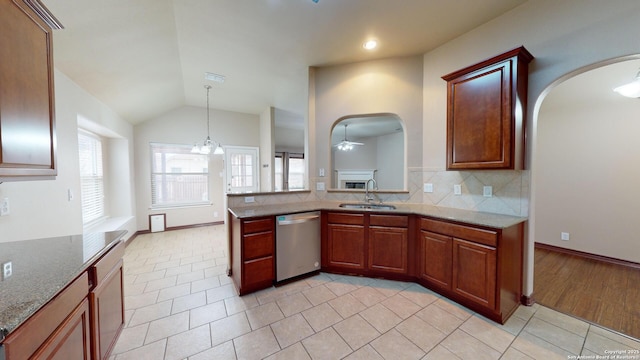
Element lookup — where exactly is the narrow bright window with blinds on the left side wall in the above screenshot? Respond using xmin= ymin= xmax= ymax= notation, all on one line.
xmin=78 ymin=130 xmax=105 ymax=227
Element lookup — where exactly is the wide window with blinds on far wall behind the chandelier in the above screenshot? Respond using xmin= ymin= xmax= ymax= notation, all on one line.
xmin=150 ymin=143 xmax=209 ymax=207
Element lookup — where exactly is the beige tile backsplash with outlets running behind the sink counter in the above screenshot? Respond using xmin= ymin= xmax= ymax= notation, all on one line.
xmin=228 ymin=168 xmax=530 ymax=216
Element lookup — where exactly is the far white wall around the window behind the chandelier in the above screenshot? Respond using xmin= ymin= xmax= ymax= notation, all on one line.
xmin=134 ymin=106 xmax=260 ymax=230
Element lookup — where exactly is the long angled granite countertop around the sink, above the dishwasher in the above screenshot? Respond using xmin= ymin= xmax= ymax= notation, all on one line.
xmin=229 ymin=201 xmax=527 ymax=229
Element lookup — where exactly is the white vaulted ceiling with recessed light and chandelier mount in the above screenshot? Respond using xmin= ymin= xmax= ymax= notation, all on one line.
xmin=43 ymin=0 xmax=526 ymax=124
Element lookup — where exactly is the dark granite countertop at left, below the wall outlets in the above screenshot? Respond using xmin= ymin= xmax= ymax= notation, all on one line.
xmin=0 ymin=231 xmax=126 ymax=338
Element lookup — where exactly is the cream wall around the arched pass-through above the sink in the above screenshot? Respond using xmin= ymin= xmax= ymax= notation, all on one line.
xmin=310 ymin=56 xmax=423 ymax=188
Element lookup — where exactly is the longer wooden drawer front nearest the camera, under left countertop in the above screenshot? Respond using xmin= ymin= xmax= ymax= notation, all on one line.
xmin=3 ymin=272 xmax=89 ymax=359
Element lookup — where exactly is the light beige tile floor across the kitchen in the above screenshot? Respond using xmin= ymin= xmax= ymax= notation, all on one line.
xmin=111 ymin=226 xmax=640 ymax=360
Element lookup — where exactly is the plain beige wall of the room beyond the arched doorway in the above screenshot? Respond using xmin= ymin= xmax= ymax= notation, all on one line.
xmin=534 ymin=97 xmax=640 ymax=262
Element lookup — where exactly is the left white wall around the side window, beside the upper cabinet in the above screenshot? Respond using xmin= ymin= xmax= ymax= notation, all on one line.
xmin=0 ymin=70 xmax=136 ymax=242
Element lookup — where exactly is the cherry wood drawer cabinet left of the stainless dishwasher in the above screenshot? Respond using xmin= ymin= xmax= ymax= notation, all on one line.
xmin=229 ymin=216 xmax=276 ymax=295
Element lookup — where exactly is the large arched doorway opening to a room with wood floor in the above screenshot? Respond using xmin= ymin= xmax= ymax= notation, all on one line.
xmin=531 ymin=58 xmax=640 ymax=338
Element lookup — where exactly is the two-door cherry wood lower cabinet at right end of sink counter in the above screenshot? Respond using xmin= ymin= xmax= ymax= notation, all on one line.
xmin=418 ymin=217 xmax=523 ymax=323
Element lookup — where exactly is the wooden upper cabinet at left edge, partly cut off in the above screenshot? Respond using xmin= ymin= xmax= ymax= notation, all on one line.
xmin=0 ymin=0 xmax=61 ymax=182
